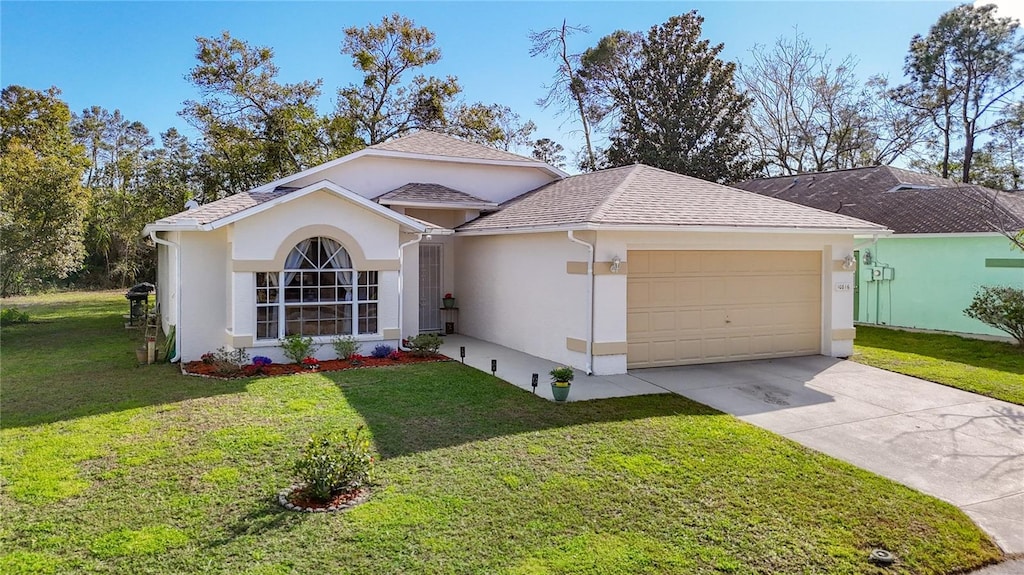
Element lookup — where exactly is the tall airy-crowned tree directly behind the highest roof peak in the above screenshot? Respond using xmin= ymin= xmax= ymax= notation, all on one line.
xmin=337 ymin=13 xmax=462 ymax=145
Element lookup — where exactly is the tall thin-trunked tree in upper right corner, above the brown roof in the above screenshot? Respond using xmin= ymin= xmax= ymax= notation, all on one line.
xmin=899 ymin=4 xmax=1024 ymax=182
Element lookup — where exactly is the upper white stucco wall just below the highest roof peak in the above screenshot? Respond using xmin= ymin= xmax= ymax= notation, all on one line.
xmin=289 ymin=157 xmax=555 ymax=203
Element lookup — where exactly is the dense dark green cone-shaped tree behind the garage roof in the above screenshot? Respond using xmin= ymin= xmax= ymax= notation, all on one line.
xmin=607 ymin=11 xmax=758 ymax=182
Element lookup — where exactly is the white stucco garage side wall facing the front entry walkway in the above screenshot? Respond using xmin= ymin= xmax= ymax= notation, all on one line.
xmin=455 ymin=232 xmax=588 ymax=368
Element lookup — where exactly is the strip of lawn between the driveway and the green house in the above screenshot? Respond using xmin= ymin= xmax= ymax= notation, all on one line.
xmin=852 ymin=325 xmax=1024 ymax=405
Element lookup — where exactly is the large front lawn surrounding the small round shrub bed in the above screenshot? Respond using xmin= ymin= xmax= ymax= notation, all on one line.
xmin=0 ymin=294 xmax=1000 ymax=575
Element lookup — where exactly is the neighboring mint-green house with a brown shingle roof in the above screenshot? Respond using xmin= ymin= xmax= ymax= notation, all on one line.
xmin=734 ymin=166 xmax=1024 ymax=337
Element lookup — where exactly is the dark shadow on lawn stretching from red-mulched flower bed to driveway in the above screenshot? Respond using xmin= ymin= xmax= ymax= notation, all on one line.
xmin=327 ymin=361 xmax=721 ymax=457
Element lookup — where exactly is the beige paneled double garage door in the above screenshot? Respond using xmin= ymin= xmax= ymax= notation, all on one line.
xmin=627 ymin=251 xmax=821 ymax=367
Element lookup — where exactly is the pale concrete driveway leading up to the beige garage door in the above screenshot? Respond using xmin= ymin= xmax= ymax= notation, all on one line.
xmin=630 ymin=356 xmax=1024 ymax=554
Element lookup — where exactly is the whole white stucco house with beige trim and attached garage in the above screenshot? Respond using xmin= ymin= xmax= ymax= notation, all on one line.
xmin=144 ymin=132 xmax=887 ymax=374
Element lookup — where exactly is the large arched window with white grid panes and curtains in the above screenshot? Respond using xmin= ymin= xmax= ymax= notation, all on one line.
xmin=256 ymin=237 xmax=378 ymax=340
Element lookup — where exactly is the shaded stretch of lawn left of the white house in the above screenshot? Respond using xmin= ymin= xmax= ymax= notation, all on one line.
xmin=0 ymin=300 xmax=247 ymax=429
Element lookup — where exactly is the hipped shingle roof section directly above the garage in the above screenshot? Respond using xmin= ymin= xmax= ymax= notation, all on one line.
xmin=459 ymin=165 xmax=884 ymax=231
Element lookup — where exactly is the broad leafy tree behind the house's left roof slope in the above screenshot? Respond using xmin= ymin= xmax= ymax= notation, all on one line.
xmin=181 ymin=32 xmax=344 ymax=195
